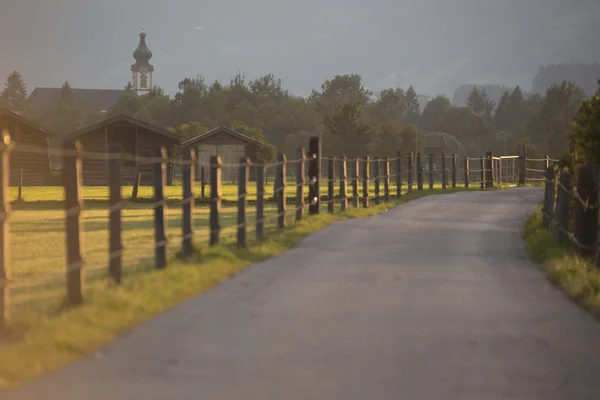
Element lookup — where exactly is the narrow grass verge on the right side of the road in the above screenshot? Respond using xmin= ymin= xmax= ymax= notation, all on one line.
xmin=523 ymin=209 xmax=600 ymax=318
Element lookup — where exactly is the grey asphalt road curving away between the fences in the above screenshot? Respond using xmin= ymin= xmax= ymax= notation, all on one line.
xmin=0 ymin=188 xmax=600 ymax=400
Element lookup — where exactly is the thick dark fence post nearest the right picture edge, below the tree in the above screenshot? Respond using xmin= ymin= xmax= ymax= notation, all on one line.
xmin=574 ymin=164 xmax=598 ymax=258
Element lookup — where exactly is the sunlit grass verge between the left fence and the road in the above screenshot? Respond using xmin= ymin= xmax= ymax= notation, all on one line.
xmin=0 ymin=184 xmax=478 ymax=387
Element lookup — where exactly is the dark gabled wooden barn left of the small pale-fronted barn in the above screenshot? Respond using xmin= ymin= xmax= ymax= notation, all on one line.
xmin=64 ymin=115 xmax=183 ymax=186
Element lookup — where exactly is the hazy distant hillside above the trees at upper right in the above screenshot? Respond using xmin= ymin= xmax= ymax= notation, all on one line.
xmin=531 ymin=63 xmax=600 ymax=96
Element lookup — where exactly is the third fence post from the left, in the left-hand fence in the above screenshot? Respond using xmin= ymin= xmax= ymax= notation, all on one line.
xmin=108 ymin=144 xmax=123 ymax=285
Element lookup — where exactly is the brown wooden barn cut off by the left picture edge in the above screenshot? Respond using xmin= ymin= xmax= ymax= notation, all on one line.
xmin=0 ymin=108 xmax=56 ymax=186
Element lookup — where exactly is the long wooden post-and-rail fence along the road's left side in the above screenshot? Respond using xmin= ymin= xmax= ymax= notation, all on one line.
xmin=0 ymin=135 xmax=549 ymax=327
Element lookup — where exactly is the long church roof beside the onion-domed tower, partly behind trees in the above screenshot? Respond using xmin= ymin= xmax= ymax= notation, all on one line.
xmin=27 ymin=87 xmax=125 ymax=111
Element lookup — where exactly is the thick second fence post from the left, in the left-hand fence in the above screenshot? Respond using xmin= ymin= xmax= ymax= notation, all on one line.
xmin=63 ymin=140 xmax=84 ymax=306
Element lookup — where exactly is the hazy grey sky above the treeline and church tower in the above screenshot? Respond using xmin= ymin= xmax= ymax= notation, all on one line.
xmin=0 ymin=0 xmax=600 ymax=95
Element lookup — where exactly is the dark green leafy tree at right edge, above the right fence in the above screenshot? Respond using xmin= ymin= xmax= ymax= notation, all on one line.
xmin=567 ymin=81 xmax=600 ymax=164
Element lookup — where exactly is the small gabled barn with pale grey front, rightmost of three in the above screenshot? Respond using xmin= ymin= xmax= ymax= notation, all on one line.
xmin=182 ymin=126 xmax=262 ymax=182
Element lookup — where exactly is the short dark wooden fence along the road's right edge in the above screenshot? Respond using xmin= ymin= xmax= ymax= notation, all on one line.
xmin=542 ymin=164 xmax=600 ymax=267
